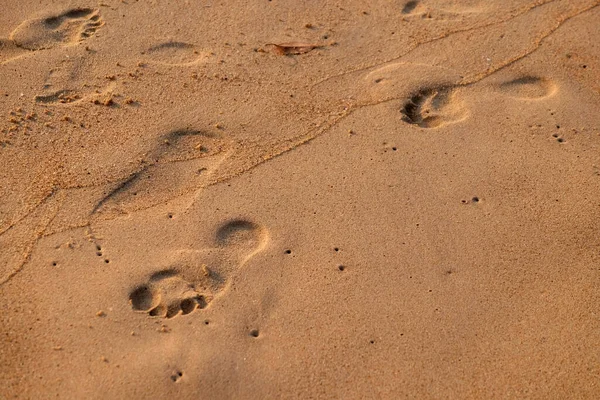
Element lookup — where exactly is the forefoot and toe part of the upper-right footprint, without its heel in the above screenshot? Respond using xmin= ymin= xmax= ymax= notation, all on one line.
xmin=402 ymin=87 xmax=468 ymax=128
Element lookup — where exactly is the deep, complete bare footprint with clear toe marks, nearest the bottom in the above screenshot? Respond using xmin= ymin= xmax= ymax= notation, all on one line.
xmin=129 ymin=219 xmax=268 ymax=318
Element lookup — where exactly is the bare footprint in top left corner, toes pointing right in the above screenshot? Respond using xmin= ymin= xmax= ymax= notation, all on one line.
xmin=10 ymin=8 xmax=104 ymax=50
